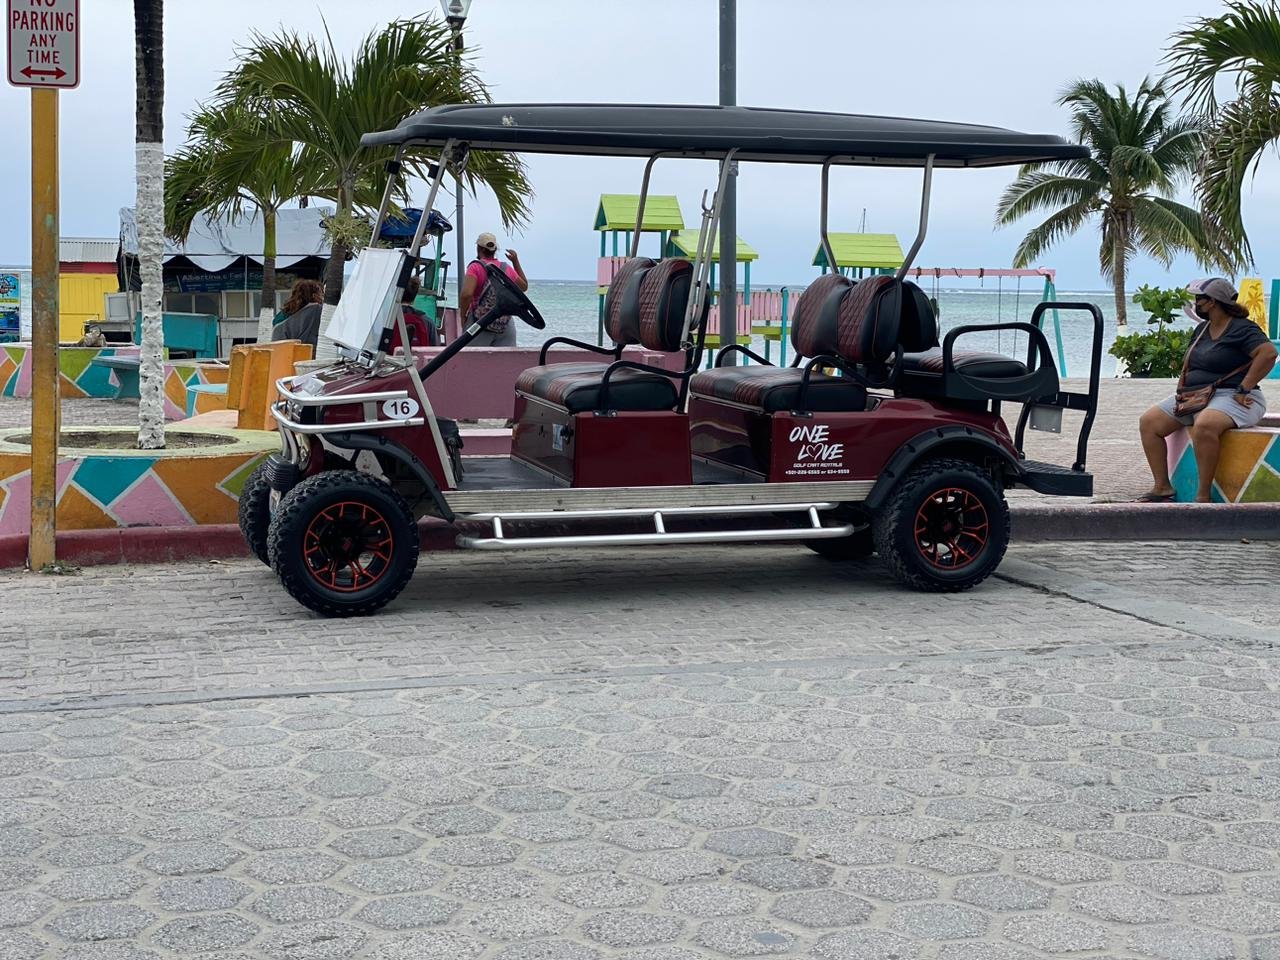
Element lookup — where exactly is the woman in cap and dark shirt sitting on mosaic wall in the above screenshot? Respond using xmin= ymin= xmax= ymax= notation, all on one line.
xmin=1138 ymin=278 xmax=1276 ymax=503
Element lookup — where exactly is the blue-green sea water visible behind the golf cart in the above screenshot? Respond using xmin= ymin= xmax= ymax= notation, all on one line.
xmin=448 ymin=280 xmax=1190 ymax=376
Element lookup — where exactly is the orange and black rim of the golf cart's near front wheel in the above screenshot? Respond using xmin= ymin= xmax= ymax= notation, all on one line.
xmin=302 ymin=500 xmax=396 ymax=594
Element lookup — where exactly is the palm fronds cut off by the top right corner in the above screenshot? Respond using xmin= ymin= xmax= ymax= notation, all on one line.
xmin=1165 ymin=3 xmax=1280 ymax=262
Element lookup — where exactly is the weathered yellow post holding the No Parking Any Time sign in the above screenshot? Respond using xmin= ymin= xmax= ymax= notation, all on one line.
xmin=27 ymin=88 xmax=61 ymax=570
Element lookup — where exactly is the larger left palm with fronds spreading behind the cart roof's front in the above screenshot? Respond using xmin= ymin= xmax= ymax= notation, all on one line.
xmin=219 ymin=17 xmax=531 ymax=357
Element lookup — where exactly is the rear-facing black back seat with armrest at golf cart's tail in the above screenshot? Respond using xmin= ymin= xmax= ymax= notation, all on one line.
xmin=896 ymin=282 xmax=1059 ymax=401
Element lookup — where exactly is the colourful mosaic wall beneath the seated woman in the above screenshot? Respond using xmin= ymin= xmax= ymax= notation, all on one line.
xmin=1169 ymin=426 xmax=1280 ymax=503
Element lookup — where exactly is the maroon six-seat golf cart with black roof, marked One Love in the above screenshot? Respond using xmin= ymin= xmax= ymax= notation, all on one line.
xmin=241 ymin=105 xmax=1102 ymax=616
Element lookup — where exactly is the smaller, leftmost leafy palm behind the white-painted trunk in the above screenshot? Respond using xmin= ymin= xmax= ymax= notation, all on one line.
xmin=165 ymin=101 xmax=328 ymax=342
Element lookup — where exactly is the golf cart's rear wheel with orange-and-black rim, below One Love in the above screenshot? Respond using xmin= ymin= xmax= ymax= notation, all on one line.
xmin=873 ymin=460 xmax=1009 ymax=593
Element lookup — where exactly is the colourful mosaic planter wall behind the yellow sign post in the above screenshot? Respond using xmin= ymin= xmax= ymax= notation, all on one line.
xmin=0 ymin=428 xmax=279 ymax=536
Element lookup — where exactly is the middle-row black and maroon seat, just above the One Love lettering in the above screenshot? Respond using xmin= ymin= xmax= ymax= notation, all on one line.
xmin=690 ymin=274 xmax=899 ymax=413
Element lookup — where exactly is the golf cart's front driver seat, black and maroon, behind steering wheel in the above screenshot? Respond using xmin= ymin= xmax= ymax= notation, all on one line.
xmin=516 ymin=257 xmax=692 ymax=413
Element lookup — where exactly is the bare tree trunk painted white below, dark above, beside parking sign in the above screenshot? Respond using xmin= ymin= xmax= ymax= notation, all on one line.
xmin=133 ymin=0 xmax=164 ymax=451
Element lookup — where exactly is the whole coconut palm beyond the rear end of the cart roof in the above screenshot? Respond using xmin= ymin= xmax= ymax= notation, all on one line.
xmin=996 ymin=79 xmax=1238 ymax=325
